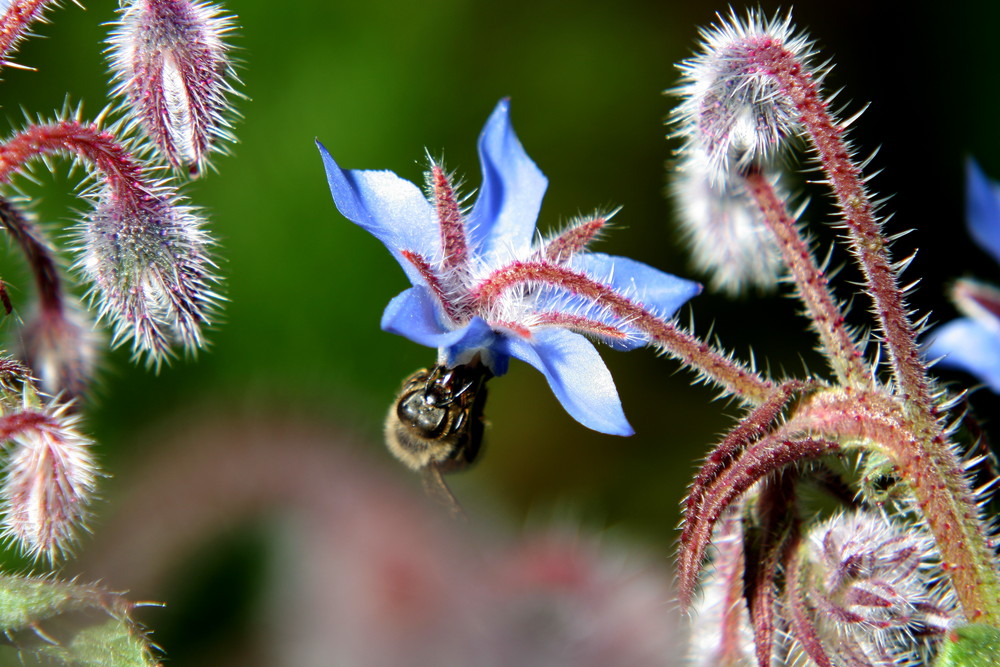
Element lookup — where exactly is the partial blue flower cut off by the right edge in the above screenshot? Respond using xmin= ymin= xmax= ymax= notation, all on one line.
xmin=926 ymin=160 xmax=1000 ymax=393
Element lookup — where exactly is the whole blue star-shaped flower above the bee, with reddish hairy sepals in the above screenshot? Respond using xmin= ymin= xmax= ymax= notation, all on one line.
xmin=319 ymin=100 xmax=701 ymax=435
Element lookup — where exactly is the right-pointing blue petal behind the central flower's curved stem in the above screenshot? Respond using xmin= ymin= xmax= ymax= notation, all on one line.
xmin=570 ymin=252 xmax=701 ymax=350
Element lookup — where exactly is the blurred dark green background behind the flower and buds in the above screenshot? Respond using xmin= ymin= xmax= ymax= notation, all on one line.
xmin=0 ymin=0 xmax=1000 ymax=664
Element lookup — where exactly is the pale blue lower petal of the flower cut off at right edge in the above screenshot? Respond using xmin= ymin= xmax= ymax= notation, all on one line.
xmin=925 ymin=317 xmax=1000 ymax=394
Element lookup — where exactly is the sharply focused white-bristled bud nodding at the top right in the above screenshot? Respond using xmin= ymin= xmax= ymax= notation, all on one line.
xmin=673 ymin=12 xmax=810 ymax=186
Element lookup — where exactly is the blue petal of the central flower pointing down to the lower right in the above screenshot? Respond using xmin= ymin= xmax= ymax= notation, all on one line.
xmin=507 ymin=329 xmax=634 ymax=435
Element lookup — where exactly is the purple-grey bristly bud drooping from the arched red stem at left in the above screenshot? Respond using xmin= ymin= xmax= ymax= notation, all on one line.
xmin=77 ymin=181 xmax=220 ymax=365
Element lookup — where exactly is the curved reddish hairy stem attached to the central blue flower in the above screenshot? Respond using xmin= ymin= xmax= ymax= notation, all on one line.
xmin=472 ymin=262 xmax=775 ymax=405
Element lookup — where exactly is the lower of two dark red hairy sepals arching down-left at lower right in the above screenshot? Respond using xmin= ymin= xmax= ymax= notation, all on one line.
xmin=677 ymin=429 xmax=841 ymax=609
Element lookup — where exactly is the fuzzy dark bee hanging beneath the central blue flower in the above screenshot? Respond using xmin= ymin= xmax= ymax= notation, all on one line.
xmin=385 ymin=363 xmax=493 ymax=515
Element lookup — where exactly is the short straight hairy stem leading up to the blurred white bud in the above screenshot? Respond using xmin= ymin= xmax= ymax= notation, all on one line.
xmin=745 ymin=169 xmax=871 ymax=388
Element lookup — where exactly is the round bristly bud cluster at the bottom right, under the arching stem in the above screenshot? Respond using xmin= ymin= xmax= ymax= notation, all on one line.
xmin=800 ymin=512 xmax=957 ymax=665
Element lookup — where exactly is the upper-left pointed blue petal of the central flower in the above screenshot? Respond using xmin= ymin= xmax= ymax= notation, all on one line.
xmin=316 ymin=141 xmax=440 ymax=285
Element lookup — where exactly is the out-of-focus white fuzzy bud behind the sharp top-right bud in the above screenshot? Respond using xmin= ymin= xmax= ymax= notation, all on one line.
xmin=673 ymin=152 xmax=782 ymax=294
